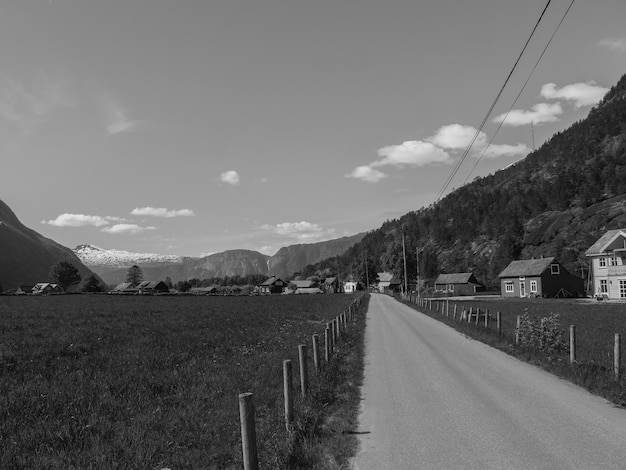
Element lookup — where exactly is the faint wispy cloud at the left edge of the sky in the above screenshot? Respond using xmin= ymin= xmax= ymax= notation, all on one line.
xmin=0 ymin=74 xmax=76 ymax=135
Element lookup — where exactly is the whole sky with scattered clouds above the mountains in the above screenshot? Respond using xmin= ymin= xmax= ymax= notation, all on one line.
xmin=0 ymin=0 xmax=626 ymax=256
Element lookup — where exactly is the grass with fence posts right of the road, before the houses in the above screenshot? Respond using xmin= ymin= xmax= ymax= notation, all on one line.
xmin=404 ymin=297 xmax=626 ymax=406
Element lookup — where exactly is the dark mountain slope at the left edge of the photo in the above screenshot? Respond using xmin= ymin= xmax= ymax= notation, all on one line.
xmin=0 ymin=200 xmax=100 ymax=291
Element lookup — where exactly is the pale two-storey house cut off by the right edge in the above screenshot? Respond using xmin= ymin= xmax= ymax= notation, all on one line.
xmin=585 ymin=228 xmax=626 ymax=300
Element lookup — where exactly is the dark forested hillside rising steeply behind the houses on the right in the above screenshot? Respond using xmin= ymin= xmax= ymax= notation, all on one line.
xmin=305 ymin=75 xmax=626 ymax=286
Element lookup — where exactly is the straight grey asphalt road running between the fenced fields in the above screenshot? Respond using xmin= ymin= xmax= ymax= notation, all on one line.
xmin=353 ymin=294 xmax=626 ymax=470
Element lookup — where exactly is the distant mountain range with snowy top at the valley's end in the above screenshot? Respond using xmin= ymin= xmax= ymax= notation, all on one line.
xmin=74 ymin=234 xmax=365 ymax=284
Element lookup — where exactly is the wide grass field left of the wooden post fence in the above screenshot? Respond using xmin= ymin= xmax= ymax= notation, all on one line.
xmin=0 ymin=295 xmax=364 ymax=469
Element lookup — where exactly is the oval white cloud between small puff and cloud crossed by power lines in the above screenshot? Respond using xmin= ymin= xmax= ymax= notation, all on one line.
xmin=370 ymin=140 xmax=452 ymax=167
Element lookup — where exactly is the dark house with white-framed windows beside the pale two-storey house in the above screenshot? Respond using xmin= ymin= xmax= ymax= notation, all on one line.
xmin=498 ymin=257 xmax=585 ymax=297
